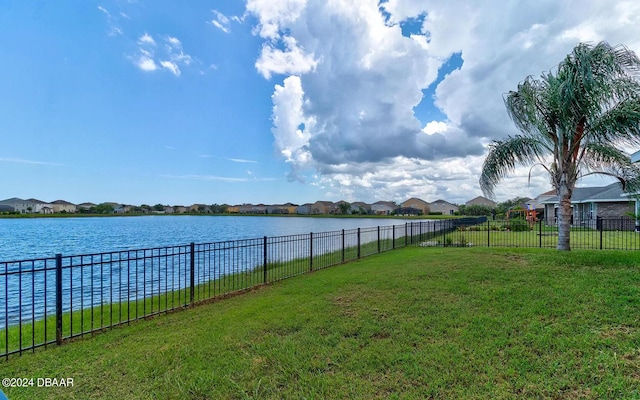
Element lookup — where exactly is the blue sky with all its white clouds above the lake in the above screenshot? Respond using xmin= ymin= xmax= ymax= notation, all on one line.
xmin=0 ymin=0 xmax=640 ymax=205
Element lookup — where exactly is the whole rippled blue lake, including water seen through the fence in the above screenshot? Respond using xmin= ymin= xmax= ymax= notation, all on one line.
xmin=0 ymin=216 xmax=436 ymax=329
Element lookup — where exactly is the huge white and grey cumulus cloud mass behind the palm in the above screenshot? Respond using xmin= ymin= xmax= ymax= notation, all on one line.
xmin=246 ymin=0 xmax=640 ymax=202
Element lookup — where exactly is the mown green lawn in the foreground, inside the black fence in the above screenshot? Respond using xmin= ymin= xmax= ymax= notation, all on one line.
xmin=0 ymin=247 xmax=640 ymax=400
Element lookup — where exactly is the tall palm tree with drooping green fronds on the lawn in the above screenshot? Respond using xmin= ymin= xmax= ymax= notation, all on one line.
xmin=480 ymin=42 xmax=640 ymax=250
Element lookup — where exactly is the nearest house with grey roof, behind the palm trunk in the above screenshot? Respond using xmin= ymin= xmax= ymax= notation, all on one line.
xmin=541 ymin=182 xmax=635 ymax=228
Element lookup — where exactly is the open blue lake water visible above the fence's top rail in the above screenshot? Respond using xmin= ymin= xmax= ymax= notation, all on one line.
xmin=0 ymin=215 xmax=418 ymax=262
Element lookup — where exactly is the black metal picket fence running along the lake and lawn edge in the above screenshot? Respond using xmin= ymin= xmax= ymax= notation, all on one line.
xmin=5 ymin=217 xmax=640 ymax=358
